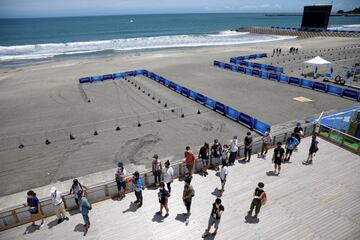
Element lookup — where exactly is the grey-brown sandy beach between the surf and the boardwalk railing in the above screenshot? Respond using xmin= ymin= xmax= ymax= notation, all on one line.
xmin=0 ymin=38 xmax=358 ymax=208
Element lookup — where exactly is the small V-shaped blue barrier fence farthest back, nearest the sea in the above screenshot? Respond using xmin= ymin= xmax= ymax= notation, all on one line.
xmin=230 ymin=53 xmax=284 ymax=73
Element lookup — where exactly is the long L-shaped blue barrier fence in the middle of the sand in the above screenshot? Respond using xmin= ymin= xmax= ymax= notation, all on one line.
xmin=79 ymin=68 xmax=271 ymax=133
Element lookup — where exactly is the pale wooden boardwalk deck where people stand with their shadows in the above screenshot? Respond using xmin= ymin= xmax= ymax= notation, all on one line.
xmin=0 ymin=138 xmax=360 ymax=240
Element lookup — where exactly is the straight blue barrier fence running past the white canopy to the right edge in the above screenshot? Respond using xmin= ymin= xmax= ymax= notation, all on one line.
xmin=214 ymin=61 xmax=360 ymax=101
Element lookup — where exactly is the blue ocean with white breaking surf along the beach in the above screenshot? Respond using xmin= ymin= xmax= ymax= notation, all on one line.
xmin=0 ymin=13 xmax=360 ymax=67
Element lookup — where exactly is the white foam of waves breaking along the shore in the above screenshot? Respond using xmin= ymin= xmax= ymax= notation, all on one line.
xmin=0 ymin=31 xmax=293 ymax=62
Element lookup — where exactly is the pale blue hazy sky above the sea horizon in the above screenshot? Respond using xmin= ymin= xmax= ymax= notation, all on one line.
xmin=0 ymin=0 xmax=360 ymax=18
